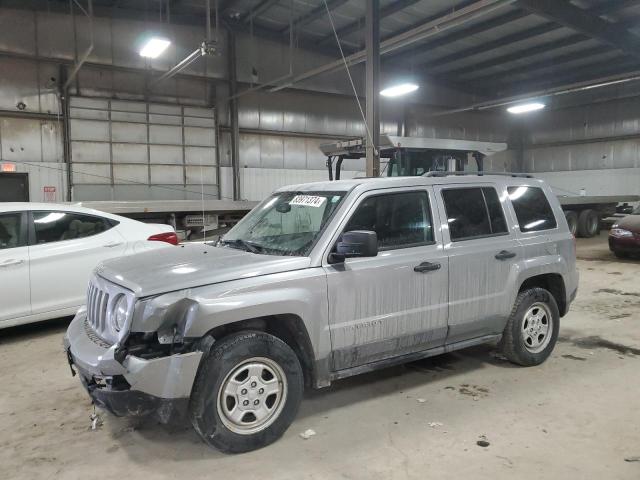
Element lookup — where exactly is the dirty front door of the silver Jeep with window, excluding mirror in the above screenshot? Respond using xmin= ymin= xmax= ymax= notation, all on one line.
xmin=324 ymin=187 xmax=448 ymax=370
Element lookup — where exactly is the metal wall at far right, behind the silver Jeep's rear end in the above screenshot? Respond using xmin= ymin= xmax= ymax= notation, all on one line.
xmin=524 ymin=97 xmax=640 ymax=195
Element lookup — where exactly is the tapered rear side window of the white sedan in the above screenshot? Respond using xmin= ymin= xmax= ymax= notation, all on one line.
xmin=33 ymin=211 xmax=113 ymax=244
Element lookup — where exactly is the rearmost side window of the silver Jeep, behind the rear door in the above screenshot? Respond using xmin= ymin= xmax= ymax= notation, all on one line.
xmin=507 ymin=186 xmax=557 ymax=232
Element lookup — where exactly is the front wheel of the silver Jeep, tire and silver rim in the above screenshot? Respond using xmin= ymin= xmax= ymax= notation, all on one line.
xmin=189 ymin=331 xmax=304 ymax=453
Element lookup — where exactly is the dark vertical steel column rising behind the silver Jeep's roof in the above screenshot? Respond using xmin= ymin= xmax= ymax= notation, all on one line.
xmin=365 ymin=0 xmax=380 ymax=177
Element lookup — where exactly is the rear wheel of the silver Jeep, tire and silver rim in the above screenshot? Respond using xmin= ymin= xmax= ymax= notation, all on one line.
xmin=499 ymin=288 xmax=560 ymax=367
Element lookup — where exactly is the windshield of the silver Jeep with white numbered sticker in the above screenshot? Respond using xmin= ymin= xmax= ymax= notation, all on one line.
xmin=220 ymin=192 xmax=347 ymax=256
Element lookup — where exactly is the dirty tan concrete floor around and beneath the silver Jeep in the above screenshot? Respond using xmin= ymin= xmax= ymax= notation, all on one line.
xmin=0 ymin=234 xmax=640 ymax=480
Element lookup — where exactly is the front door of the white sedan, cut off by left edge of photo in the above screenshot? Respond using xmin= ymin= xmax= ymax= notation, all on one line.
xmin=0 ymin=212 xmax=31 ymax=322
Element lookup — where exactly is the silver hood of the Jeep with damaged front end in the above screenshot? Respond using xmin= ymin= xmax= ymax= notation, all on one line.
xmin=96 ymin=244 xmax=311 ymax=297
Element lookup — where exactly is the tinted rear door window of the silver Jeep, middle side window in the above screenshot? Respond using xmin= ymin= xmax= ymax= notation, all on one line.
xmin=442 ymin=187 xmax=508 ymax=242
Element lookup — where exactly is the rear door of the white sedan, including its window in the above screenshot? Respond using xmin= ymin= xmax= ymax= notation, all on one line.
xmin=29 ymin=210 xmax=125 ymax=314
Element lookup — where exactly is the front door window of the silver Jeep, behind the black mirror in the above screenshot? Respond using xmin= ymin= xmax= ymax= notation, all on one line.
xmin=344 ymin=192 xmax=433 ymax=250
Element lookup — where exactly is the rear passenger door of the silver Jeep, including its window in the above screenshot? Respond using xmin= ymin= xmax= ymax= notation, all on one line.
xmin=436 ymin=184 xmax=522 ymax=343
